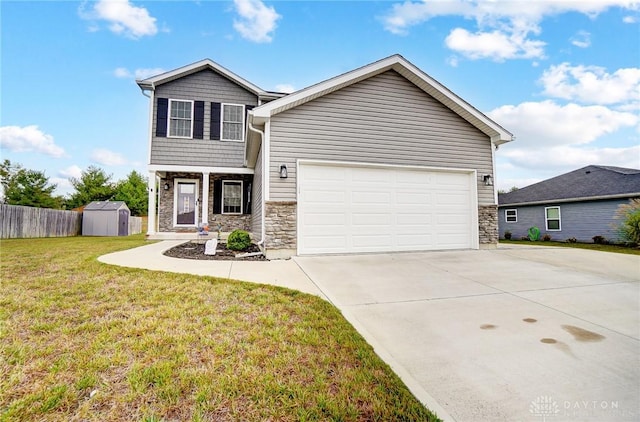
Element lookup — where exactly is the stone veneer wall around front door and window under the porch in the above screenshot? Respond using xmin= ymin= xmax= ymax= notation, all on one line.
xmin=158 ymin=173 xmax=251 ymax=233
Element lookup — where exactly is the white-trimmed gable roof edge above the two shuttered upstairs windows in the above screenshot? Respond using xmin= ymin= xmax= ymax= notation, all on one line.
xmin=136 ymin=59 xmax=285 ymax=99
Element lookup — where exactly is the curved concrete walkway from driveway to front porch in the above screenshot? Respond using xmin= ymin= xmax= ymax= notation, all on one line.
xmin=98 ymin=240 xmax=326 ymax=299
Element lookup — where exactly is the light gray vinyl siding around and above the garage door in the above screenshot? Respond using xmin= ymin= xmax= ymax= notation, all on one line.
xmin=269 ymin=71 xmax=495 ymax=205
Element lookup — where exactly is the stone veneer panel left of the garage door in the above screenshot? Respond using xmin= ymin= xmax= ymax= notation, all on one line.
xmin=264 ymin=201 xmax=298 ymax=249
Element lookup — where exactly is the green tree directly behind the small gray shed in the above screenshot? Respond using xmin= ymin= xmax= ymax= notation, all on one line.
xmin=66 ymin=166 xmax=115 ymax=209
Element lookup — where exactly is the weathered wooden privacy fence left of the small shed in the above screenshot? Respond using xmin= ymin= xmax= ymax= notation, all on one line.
xmin=0 ymin=204 xmax=82 ymax=239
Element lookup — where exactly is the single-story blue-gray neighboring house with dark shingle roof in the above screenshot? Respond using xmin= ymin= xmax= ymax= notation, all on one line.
xmin=498 ymin=165 xmax=640 ymax=242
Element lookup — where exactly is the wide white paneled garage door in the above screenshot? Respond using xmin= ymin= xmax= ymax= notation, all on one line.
xmin=298 ymin=162 xmax=478 ymax=254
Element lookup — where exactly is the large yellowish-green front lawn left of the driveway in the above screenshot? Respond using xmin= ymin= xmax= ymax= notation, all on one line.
xmin=0 ymin=236 xmax=437 ymax=421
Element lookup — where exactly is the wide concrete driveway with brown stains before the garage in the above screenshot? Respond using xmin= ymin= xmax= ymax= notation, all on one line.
xmin=295 ymin=246 xmax=640 ymax=422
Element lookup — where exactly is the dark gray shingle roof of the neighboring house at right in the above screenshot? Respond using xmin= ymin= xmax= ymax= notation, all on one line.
xmin=498 ymin=165 xmax=640 ymax=206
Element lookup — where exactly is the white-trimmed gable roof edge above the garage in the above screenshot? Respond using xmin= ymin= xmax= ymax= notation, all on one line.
xmin=250 ymin=54 xmax=514 ymax=145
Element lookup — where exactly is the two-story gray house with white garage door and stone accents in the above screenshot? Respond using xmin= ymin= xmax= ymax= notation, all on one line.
xmin=138 ymin=55 xmax=513 ymax=257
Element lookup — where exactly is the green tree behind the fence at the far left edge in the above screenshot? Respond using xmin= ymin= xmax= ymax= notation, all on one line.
xmin=0 ymin=159 xmax=63 ymax=208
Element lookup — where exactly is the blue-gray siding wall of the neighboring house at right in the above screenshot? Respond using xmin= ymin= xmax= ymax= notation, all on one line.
xmin=498 ymin=199 xmax=628 ymax=242
